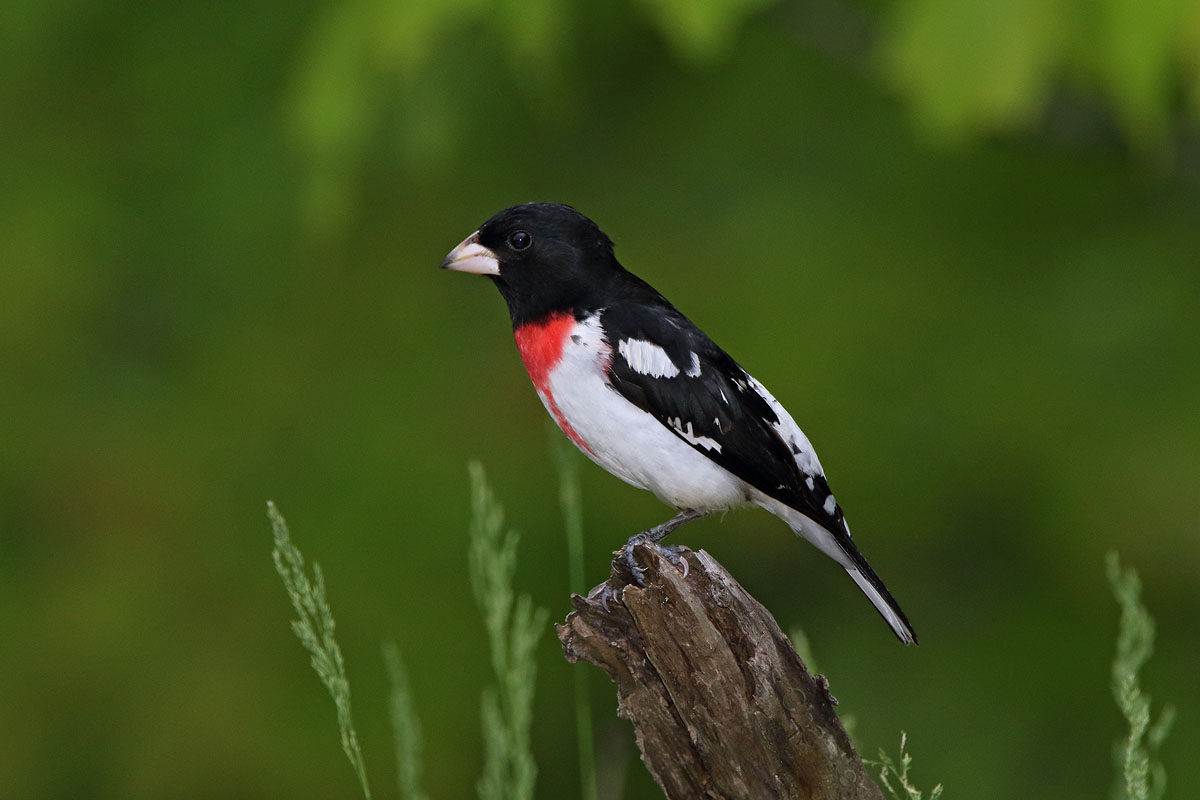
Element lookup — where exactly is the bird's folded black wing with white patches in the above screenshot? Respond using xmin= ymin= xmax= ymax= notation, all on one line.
xmin=601 ymin=299 xmax=848 ymax=537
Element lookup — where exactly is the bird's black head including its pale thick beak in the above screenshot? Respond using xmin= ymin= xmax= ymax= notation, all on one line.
xmin=442 ymin=203 xmax=624 ymax=326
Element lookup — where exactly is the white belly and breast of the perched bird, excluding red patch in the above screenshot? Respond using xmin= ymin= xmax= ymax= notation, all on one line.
xmin=538 ymin=319 xmax=749 ymax=511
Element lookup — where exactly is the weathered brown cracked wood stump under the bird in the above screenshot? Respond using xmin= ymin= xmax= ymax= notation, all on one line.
xmin=557 ymin=545 xmax=883 ymax=800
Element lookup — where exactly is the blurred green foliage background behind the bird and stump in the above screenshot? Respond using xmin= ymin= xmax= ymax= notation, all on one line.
xmin=0 ymin=0 xmax=1200 ymax=800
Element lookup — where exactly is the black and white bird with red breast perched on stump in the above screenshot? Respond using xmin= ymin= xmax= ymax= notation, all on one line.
xmin=442 ymin=203 xmax=918 ymax=644
